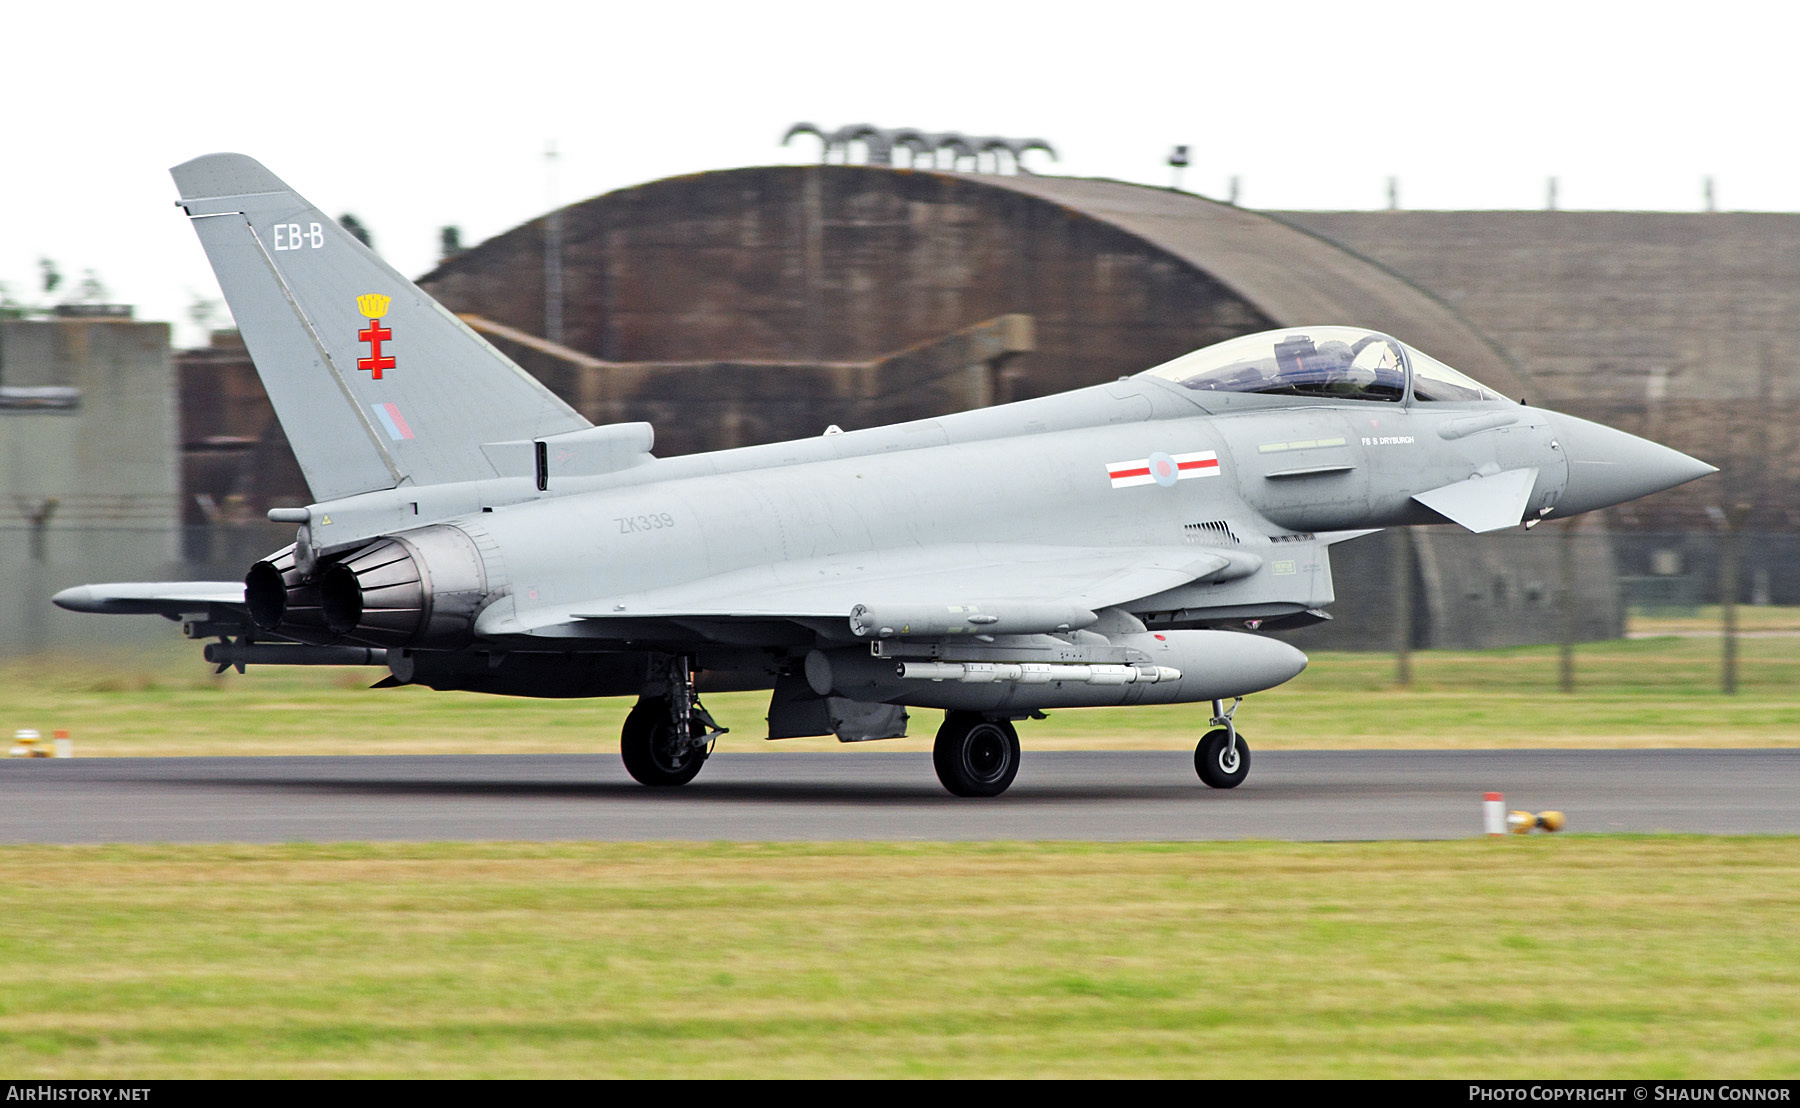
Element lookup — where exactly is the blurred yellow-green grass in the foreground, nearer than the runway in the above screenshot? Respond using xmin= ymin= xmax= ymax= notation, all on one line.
xmin=0 ymin=836 xmax=1800 ymax=1079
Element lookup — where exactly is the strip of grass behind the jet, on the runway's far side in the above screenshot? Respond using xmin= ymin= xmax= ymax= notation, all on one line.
xmin=0 ymin=608 xmax=1800 ymax=755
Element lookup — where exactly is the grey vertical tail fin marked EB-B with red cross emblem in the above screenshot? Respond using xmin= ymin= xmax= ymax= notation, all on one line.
xmin=169 ymin=155 xmax=590 ymax=500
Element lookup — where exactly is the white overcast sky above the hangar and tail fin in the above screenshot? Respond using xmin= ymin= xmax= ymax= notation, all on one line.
xmin=0 ymin=0 xmax=1800 ymax=340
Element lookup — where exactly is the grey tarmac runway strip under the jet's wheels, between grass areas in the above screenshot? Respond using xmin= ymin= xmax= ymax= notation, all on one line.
xmin=0 ymin=750 xmax=1800 ymax=844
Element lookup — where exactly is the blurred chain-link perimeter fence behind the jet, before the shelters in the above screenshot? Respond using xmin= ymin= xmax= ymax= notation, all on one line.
xmin=0 ymin=522 xmax=1800 ymax=655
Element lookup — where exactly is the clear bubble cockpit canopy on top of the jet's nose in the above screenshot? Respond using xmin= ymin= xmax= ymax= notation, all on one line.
xmin=1139 ymin=327 xmax=1501 ymax=403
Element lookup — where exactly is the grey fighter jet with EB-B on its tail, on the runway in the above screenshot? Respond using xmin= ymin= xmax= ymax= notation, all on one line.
xmin=56 ymin=155 xmax=1714 ymax=797
